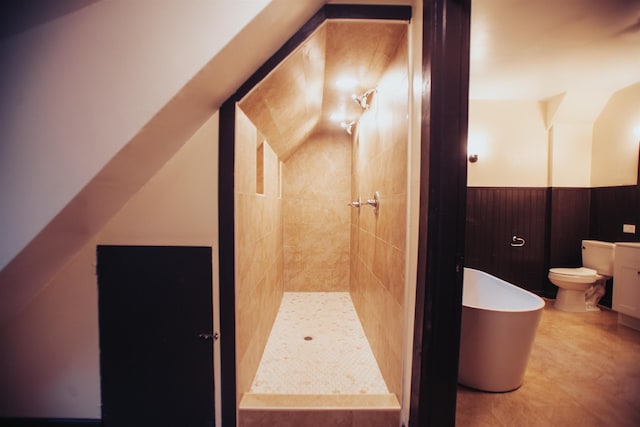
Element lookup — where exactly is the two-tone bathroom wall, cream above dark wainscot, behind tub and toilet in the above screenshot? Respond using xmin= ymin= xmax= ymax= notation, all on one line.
xmin=465 ymin=83 xmax=640 ymax=307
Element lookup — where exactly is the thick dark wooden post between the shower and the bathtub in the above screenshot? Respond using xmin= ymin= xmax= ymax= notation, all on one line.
xmin=409 ymin=0 xmax=471 ymax=426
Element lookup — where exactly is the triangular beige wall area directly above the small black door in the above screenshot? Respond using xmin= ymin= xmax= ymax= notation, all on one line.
xmin=98 ymin=112 xmax=218 ymax=246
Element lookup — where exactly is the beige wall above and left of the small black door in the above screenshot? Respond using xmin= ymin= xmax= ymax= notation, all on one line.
xmin=0 ymin=113 xmax=218 ymax=418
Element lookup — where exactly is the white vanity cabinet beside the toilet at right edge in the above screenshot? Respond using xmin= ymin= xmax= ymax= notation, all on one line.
xmin=613 ymin=243 xmax=640 ymax=329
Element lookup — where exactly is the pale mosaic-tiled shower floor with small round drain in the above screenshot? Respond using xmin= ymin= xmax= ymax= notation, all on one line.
xmin=250 ymin=292 xmax=389 ymax=394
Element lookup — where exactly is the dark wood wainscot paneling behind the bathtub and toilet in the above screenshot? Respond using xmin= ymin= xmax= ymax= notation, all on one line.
xmin=465 ymin=186 xmax=640 ymax=306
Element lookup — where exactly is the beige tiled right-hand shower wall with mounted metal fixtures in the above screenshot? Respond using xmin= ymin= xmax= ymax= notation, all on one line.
xmin=350 ymin=27 xmax=408 ymax=399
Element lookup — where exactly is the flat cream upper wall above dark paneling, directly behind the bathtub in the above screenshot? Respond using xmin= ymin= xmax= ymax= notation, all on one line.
xmin=467 ymin=100 xmax=549 ymax=187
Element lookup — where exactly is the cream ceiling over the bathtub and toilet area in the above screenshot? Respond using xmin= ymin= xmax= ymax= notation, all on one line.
xmin=470 ymin=0 xmax=640 ymax=100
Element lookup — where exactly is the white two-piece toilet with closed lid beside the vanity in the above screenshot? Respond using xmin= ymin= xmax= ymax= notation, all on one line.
xmin=549 ymin=240 xmax=616 ymax=312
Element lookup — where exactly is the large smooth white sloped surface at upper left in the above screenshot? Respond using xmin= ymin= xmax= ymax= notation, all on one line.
xmin=0 ymin=0 xmax=272 ymax=270
